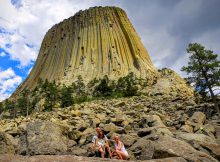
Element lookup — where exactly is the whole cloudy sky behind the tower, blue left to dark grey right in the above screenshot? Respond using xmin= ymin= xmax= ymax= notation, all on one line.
xmin=0 ymin=0 xmax=220 ymax=101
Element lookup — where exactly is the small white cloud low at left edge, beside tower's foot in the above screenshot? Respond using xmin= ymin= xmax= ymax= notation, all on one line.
xmin=0 ymin=68 xmax=22 ymax=101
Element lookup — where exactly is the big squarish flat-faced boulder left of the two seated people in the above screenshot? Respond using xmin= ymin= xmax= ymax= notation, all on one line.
xmin=26 ymin=121 xmax=67 ymax=155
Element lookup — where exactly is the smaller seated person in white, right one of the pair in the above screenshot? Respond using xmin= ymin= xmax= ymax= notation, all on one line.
xmin=113 ymin=135 xmax=128 ymax=160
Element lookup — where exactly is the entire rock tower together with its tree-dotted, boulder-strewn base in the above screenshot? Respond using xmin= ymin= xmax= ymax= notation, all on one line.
xmin=0 ymin=7 xmax=220 ymax=162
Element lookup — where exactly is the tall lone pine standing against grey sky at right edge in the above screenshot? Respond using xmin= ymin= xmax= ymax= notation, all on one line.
xmin=181 ymin=43 xmax=220 ymax=112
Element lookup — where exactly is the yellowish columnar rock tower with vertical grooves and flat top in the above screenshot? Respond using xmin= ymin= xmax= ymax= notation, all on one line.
xmin=13 ymin=7 xmax=157 ymax=95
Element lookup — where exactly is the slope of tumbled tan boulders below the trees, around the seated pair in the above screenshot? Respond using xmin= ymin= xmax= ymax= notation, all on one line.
xmin=0 ymin=95 xmax=220 ymax=162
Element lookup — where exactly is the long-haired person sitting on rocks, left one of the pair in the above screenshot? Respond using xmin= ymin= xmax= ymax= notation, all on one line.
xmin=92 ymin=127 xmax=112 ymax=158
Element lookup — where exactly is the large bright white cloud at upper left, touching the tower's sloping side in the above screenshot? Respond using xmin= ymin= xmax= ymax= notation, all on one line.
xmin=0 ymin=0 xmax=93 ymax=67
